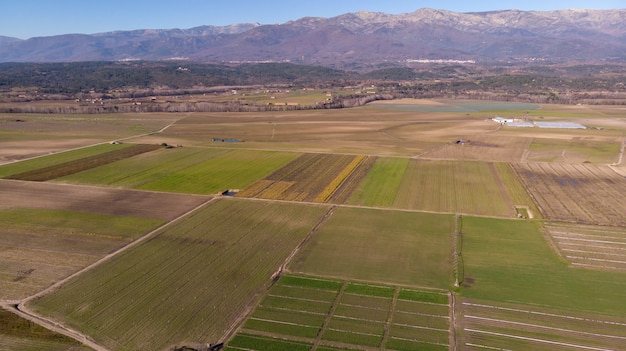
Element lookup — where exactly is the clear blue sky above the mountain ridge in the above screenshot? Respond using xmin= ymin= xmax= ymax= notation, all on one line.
xmin=0 ymin=0 xmax=626 ymax=39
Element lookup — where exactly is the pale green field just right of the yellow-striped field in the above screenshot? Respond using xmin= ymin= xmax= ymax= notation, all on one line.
xmin=348 ymin=158 xmax=534 ymax=217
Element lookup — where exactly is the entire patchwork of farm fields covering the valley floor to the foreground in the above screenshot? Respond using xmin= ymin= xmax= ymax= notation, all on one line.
xmin=0 ymin=100 xmax=626 ymax=351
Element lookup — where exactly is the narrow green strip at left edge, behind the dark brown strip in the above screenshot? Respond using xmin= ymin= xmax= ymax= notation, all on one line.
xmin=0 ymin=144 xmax=128 ymax=178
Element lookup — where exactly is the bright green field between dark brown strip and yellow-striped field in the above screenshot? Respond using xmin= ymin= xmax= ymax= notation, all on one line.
xmin=58 ymin=147 xmax=296 ymax=194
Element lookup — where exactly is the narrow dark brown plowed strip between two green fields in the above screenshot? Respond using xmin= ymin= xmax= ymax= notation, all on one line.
xmin=7 ymin=144 xmax=160 ymax=181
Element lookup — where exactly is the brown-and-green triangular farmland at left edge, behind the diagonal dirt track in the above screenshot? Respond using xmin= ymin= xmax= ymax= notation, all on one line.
xmin=0 ymin=180 xmax=209 ymax=300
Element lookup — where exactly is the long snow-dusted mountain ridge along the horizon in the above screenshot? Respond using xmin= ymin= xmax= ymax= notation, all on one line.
xmin=0 ymin=9 xmax=626 ymax=69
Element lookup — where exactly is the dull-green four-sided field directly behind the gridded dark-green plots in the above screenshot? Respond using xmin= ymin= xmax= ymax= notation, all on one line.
xmin=290 ymin=208 xmax=454 ymax=288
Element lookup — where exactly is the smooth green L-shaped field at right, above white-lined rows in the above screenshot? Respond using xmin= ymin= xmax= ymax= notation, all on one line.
xmin=459 ymin=217 xmax=626 ymax=316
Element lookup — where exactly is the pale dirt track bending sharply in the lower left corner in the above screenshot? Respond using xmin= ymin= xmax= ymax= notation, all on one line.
xmin=11 ymin=197 xmax=217 ymax=351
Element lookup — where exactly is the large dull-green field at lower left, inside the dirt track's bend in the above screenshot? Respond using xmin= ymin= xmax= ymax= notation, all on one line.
xmin=30 ymin=199 xmax=327 ymax=350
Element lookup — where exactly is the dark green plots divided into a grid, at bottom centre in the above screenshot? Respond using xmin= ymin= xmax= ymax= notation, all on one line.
xmin=226 ymin=275 xmax=450 ymax=351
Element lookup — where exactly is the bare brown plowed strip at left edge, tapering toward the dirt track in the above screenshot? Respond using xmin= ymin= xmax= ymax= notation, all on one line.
xmin=0 ymin=180 xmax=209 ymax=220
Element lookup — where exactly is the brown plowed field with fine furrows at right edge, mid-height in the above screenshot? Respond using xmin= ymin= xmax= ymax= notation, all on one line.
xmin=513 ymin=163 xmax=626 ymax=226
